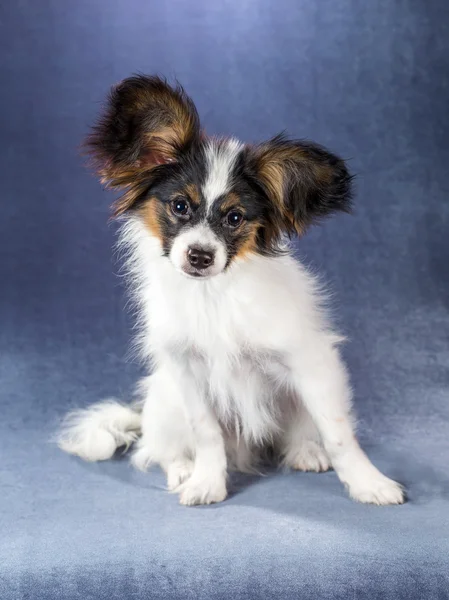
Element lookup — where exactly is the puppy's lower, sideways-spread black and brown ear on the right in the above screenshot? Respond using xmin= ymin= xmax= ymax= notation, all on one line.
xmin=247 ymin=136 xmax=352 ymax=234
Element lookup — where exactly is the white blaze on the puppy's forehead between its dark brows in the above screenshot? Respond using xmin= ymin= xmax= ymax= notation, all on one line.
xmin=203 ymin=138 xmax=243 ymax=208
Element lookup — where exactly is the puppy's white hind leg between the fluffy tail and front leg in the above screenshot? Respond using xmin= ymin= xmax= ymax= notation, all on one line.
xmin=131 ymin=367 xmax=194 ymax=491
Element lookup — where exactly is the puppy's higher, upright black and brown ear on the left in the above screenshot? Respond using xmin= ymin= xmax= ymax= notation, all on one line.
xmin=85 ymin=75 xmax=200 ymax=215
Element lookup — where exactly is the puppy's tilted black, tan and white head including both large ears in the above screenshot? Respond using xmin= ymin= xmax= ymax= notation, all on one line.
xmin=87 ymin=76 xmax=351 ymax=278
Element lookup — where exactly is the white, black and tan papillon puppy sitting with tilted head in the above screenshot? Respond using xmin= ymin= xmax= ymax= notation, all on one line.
xmin=59 ymin=75 xmax=404 ymax=505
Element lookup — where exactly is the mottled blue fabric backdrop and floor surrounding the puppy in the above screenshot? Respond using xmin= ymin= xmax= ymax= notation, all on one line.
xmin=0 ymin=0 xmax=449 ymax=600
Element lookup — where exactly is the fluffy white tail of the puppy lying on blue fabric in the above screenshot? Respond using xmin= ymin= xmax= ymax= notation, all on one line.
xmin=56 ymin=400 xmax=141 ymax=461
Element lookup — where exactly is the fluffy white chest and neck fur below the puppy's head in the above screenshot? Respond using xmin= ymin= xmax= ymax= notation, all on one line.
xmin=124 ymin=221 xmax=328 ymax=440
